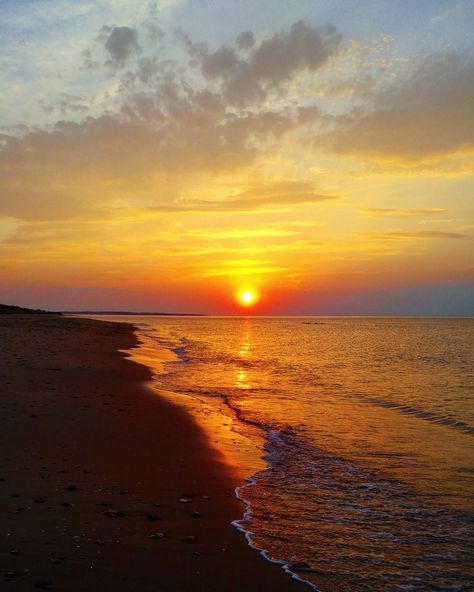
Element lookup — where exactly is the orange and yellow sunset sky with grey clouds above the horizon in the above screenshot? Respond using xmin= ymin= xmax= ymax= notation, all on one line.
xmin=0 ymin=0 xmax=474 ymax=314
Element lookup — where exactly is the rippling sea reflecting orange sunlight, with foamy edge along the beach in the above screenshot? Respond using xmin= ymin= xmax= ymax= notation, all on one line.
xmin=100 ymin=317 xmax=474 ymax=592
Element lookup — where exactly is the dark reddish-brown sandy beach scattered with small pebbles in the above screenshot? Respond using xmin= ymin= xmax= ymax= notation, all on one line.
xmin=0 ymin=315 xmax=308 ymax=592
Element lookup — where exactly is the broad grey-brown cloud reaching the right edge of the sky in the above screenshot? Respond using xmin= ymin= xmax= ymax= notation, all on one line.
xmin=322 ymin=52 xmax=474 ymax=160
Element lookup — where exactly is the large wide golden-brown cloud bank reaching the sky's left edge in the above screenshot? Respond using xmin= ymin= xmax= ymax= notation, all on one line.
xmin=0 ymin=94 xmax=320 ymax=220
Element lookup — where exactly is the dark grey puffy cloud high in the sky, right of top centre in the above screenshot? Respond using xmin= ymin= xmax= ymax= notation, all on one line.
xmin=183 ymin=21 xmax=342 ymax=106
